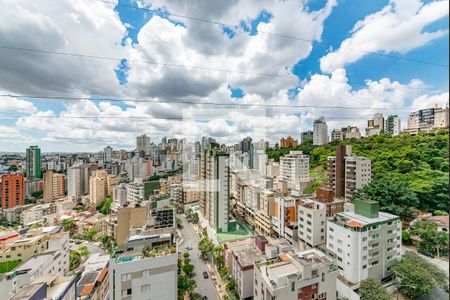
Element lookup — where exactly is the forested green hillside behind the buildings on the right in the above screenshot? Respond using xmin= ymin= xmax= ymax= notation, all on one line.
xmin=267 ymin=130 xmax=449 ymax=215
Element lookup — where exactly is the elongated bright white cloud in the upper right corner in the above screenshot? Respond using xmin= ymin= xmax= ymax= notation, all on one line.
xmin=320 ymin=0 xmax=449 ymax=72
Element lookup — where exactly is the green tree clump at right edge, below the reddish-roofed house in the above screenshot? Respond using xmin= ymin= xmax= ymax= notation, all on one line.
xmin=410 ymin=221 xmax=448 ymax=257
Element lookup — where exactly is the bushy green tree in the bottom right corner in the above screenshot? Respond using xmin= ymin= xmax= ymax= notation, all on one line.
xmin=393 ymin=252 xmax=448 ymax=298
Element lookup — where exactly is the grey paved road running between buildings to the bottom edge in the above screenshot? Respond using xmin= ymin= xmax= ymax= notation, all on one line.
xmin=177 ymin=215 xmax=219 ymax=300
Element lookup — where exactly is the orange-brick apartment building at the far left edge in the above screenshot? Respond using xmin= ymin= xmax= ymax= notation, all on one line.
xmin=1 ymin=173 xmax=25 ymax=209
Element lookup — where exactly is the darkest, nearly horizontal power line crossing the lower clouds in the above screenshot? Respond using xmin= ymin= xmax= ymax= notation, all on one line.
xmin=0 ymin=94 xmax=410 ymax=111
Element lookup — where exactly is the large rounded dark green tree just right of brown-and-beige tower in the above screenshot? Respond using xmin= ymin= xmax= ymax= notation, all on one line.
xmin=353 ymin=175 xmax=419 ymax=216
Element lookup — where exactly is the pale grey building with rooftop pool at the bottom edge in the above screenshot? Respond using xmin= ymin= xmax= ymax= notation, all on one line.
xmin=109 ymin=249 xmax=178 ymax=300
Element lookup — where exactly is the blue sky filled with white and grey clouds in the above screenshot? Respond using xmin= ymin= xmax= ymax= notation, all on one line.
xmin=0 ymin=0 xmax=449 ymax=152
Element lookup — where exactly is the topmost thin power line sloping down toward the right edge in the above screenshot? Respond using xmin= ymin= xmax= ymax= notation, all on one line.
xmin=94 ymin=0 xmax=449 ymax=68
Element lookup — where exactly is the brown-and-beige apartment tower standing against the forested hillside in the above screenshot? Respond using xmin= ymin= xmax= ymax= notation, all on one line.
xmin=327 ymin=145 xmax=372 ymax=200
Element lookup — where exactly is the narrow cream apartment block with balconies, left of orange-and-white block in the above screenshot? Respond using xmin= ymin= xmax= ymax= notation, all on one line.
xmin=255 ymin=190 xmax=275 ymax=236
